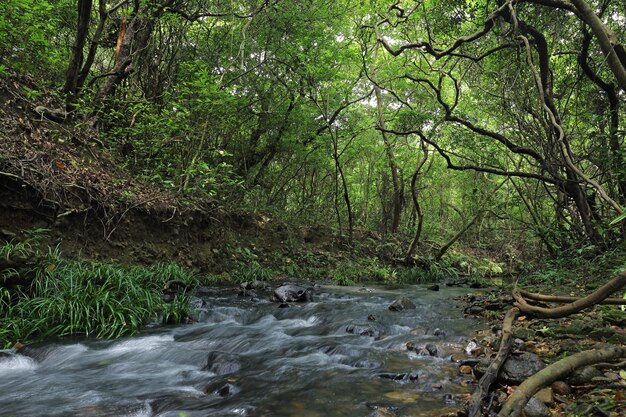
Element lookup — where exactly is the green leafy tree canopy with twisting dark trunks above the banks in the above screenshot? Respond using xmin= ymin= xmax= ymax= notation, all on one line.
xmin=0 ymin=0 xmax=626 ymax=259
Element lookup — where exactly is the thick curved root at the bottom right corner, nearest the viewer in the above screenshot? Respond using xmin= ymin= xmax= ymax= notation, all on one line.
xmin=498 ymin=346 xmax=626 ymax=417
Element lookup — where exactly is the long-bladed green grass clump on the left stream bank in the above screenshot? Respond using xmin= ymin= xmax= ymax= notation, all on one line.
xmin=0 ymin=240 xmax=197 ymax=346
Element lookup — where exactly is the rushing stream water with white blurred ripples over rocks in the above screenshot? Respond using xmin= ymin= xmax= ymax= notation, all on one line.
xmin=0 ymin=286 xmax=480 ymax=417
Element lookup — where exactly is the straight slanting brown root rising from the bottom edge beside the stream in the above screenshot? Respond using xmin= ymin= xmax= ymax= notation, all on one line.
xmin=468 ymin=307 xmax=520 ymax=417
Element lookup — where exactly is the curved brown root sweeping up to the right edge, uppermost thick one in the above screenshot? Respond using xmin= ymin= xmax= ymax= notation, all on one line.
xmin=513 ymin=272 xmax=626 ymax=318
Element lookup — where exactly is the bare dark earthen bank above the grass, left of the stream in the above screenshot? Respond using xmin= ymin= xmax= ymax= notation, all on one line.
xmin=0 ymin=172 xmax=400 ymax=274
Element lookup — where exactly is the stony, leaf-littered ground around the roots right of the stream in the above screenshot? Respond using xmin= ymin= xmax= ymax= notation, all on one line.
xmin=460 ymin=286 xmax=626 ymax=417
